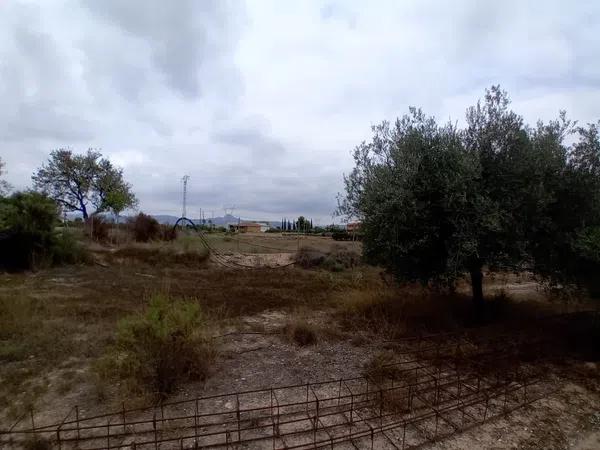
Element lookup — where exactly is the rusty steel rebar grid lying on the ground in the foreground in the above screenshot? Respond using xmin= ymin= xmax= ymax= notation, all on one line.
xmin=0 ymin=334 xmax=545 ymax=450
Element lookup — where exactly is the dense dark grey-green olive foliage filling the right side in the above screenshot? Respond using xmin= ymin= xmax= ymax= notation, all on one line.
xmin=338 ymin=86 xmax=600 ymax=305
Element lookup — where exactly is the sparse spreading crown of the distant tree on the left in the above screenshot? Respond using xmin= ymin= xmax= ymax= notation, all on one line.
xmin=32 ymin=149 xmax=137 ymax=219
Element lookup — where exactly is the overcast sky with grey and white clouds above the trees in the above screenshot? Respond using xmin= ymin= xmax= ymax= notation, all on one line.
xmin=0 ymin=0 xmax=600 ymax=222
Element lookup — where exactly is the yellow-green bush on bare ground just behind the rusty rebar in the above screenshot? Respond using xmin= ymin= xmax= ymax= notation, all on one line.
xmin=97 ymin=295 xmax=215 ymax=397
